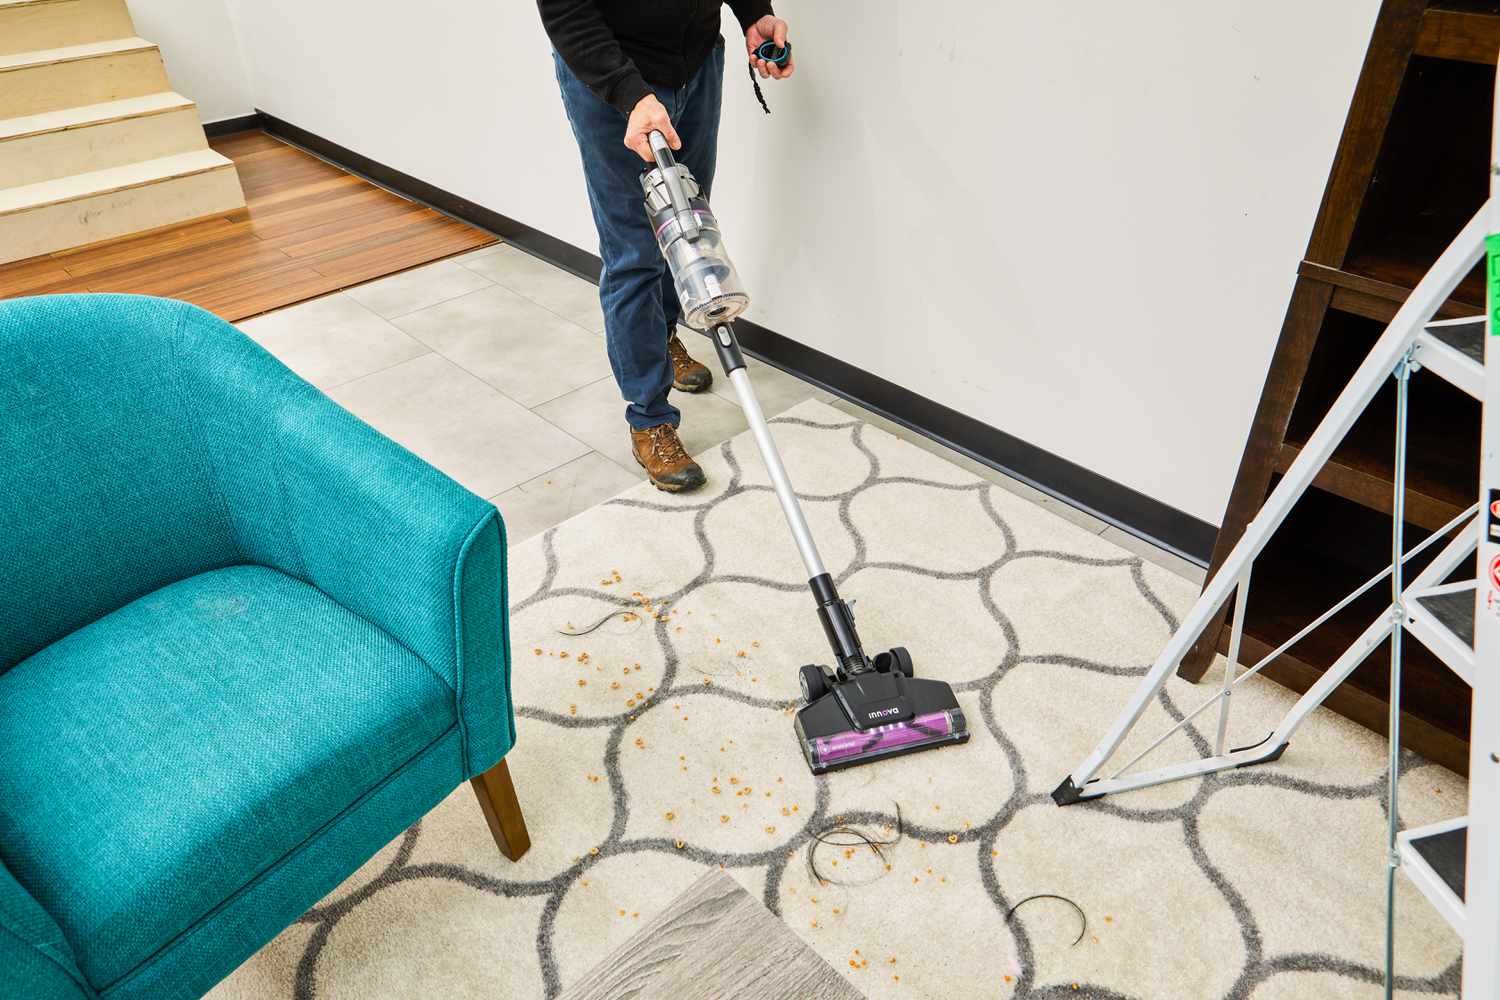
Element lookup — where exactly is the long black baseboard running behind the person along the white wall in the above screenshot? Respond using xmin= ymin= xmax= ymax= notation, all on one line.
xmin=252 ymin=111 xmax=1218 ymax=565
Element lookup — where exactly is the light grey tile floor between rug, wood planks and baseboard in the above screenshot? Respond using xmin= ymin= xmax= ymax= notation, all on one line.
xmin=240 ymin=244 xmax=1203 ymax=583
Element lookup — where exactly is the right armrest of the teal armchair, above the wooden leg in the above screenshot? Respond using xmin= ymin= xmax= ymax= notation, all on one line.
xmin=172 ymin=309 xmax=515 ymax=777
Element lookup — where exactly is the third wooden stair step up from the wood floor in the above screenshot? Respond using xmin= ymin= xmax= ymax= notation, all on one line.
xmin=0 ymin=36 xmax=171 ymax=118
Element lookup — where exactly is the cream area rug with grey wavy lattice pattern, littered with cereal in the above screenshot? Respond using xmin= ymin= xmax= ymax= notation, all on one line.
xmin=213 ymin=402 xmax=1464 ymax=1000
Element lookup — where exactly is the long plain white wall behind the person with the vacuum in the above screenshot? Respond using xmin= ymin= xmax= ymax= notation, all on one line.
xmin=230 ymin=0 xmax=1379 ymax=523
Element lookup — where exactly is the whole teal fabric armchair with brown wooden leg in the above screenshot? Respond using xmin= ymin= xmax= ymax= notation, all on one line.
xmin=0 ymin=295 xmax=528 ymax=1000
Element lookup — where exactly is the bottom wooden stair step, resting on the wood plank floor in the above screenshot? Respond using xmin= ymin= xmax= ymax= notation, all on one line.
xmin=0 ymin=148 xmax=245 ymax=262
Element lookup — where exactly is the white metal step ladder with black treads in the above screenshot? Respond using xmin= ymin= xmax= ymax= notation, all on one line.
xmin=1053 ymin=58 xmax=1500 ymax=1000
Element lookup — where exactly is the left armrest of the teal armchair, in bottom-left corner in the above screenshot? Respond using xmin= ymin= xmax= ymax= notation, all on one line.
xmin=0 ymin=865 xmax=96 ymax=1000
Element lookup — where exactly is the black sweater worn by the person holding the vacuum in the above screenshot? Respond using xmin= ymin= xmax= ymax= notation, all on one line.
xmin=537 ymin=0 xmax=771 ymax=114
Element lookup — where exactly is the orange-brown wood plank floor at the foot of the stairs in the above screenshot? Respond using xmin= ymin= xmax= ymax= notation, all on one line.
xmin=0 ymin=132 xmax=495 ymax=322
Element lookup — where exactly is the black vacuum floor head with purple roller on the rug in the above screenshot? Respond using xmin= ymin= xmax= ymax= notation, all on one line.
xmin=797 ymin=648 xmax=969 ymax=774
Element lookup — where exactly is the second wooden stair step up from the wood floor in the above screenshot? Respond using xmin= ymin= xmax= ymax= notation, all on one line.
xmin=0 ymin=91 xmax=209 ymax=189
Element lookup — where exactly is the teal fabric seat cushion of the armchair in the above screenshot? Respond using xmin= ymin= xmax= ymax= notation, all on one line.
xmin=0 ymin=565 xmax=464 ymax=990
